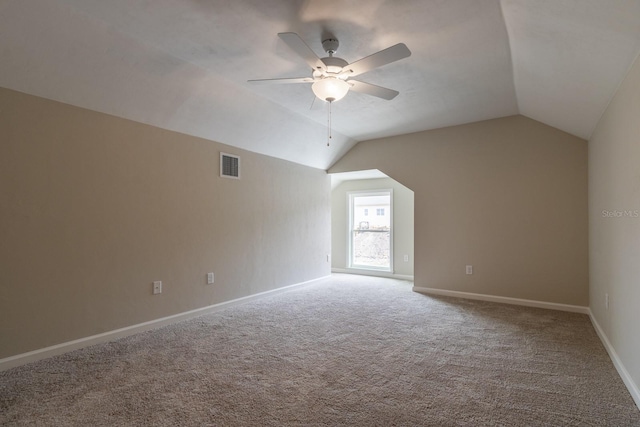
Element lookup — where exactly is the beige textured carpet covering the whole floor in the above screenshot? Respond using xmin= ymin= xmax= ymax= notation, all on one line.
xmin=0 ymin=275 xmax=640 ymax=426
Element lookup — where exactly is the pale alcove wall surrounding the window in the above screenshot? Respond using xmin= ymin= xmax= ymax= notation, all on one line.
xmin=331 ymin=178 xmax=414 ymax=276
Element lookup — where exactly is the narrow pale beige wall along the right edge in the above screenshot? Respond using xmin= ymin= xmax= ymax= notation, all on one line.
xmin=589 ymin=55 xmax=640 ymax=396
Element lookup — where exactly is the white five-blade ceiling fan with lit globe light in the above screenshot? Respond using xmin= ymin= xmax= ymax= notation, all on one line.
xmin=249 ymin=33 xmax=411 ymax=102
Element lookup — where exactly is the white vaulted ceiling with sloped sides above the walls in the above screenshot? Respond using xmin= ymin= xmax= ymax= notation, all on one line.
xmin=0 ymin=0 xmax=640 ymax=169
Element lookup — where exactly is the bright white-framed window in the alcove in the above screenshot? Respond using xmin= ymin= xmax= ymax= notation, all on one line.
xmin=348 ymin=190 xmax=393 ymax=271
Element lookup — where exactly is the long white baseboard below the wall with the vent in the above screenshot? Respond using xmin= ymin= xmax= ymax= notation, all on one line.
xmin=0 ymin=276 xmax=331 ymax=371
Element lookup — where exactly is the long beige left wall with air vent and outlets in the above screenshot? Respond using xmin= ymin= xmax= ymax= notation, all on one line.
xmin=0 ymin=89 xmax=330 ymax=358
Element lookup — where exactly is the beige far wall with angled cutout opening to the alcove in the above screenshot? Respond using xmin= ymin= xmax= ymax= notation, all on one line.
xmin=329 ymin=116 xmax=589 ymax=306
